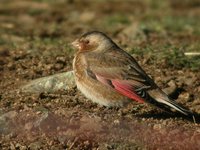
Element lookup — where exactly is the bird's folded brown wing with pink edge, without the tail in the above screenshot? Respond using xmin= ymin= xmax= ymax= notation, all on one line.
xmin=86 ymin=49 xmax=157 ymax=102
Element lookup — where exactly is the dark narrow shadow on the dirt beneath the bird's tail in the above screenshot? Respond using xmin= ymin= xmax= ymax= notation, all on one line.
xmin=136 ymin=111 xmax=200 ymax=124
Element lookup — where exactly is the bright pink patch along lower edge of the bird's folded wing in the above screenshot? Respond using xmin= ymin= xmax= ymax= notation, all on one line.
xmin=96 ymin=75 xmax=144 ymax=103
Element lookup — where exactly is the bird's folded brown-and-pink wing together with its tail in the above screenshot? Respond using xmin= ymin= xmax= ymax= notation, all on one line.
xmin=86 ymin=49 xmax=193 ymax=116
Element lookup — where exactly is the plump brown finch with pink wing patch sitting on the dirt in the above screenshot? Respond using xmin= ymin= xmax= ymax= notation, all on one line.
xmin=71 ymin=31 xmax=193 ymax=116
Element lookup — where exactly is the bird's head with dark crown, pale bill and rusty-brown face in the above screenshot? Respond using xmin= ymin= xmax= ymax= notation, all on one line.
xmin=72 ymin=31 xmax=115 ymax=52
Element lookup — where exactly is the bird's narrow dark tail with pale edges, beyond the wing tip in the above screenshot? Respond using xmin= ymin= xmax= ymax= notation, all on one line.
xmin=149 ymin=89 xmax=193 ymax=117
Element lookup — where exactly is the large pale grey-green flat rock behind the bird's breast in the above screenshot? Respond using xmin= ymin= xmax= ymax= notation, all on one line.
xmin=21 ymin=71 xmax=75 ymax=93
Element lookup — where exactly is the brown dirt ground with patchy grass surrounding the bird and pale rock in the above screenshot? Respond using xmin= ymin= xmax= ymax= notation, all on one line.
xmin=0 ymin=0 xmax=200 ymax=150
